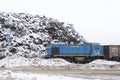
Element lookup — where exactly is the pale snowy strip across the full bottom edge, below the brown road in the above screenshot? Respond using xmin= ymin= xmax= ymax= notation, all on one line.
xmin=0 ymin=70 xmax=120 ymax=80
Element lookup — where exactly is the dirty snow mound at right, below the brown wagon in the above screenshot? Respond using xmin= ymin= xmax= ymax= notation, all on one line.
xmin=80 ymin=59 xmax=120 ymax=70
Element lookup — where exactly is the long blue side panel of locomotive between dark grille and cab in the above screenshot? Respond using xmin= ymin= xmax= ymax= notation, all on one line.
xmin=57 ymin=45 xmax=91 ymax=55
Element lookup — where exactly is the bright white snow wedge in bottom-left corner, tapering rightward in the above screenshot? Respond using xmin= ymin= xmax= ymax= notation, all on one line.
xmin=0 ymin=70 xmax=90 ymax=80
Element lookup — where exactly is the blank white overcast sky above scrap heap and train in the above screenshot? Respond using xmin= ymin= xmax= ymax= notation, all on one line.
xmin=0 ymin=0 xmax=120 ymax=44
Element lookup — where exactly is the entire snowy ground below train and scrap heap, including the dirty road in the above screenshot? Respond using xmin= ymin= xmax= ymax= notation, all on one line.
xmin=0 ymin=55 xmax=120 ymax=80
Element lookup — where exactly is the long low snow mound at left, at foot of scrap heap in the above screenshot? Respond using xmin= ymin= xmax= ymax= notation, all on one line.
xmin=0 ymin=55 xmax=71 ymax=68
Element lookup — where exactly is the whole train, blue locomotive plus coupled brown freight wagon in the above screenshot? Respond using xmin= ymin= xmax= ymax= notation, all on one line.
xmin=45 ymin=43 xmax=120 ymax=63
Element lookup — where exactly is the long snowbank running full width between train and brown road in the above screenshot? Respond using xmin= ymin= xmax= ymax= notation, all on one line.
xmin=0 ymin=55 xmax=120 ymax=70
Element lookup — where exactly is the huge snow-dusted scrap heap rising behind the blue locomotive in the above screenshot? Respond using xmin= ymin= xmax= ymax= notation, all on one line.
xmin=0 ymin=12 xmax=84 ymax=57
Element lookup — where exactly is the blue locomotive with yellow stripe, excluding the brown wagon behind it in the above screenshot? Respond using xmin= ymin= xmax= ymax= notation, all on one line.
xmin=46 ymin=43 xmax=104 ymax=62
